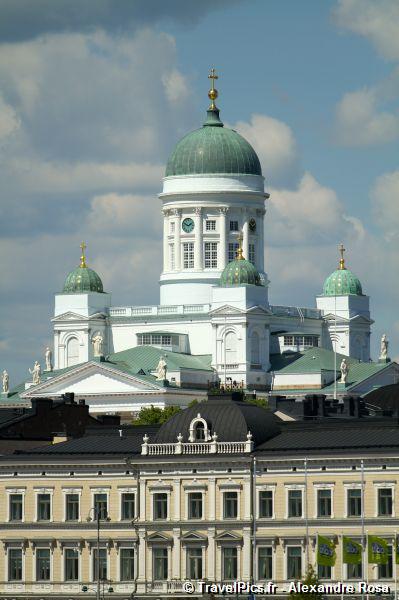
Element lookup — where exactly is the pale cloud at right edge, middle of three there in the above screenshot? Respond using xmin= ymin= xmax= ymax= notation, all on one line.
xmin=335 ymin=88 xmax=399 ymax=146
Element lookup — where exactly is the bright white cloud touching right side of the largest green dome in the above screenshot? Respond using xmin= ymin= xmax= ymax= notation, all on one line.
xmin=234 ymin=114 xmax=298 ymax=185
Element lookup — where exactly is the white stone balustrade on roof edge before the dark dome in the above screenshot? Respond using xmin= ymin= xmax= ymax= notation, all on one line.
xmin=141 ymin=431 xmax=254 ymax=456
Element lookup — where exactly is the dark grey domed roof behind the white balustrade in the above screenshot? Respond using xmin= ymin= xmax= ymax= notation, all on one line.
xmin=154 ymin=395 xmax=279 ymax=445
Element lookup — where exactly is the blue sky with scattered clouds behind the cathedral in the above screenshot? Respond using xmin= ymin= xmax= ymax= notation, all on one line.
xmin=0 ymin=0 xmax=399 ymax=384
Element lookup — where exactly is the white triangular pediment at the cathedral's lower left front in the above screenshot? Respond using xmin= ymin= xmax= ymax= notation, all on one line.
xmin=20 ymin=361 xmax=164 ymax=398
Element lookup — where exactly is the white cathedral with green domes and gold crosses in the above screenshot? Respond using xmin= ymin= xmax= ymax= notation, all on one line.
xmin=5 ymin=70 xmax=398 ymax=412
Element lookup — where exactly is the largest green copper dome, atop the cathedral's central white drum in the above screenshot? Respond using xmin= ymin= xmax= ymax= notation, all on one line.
xmin=165 ymin=108 xmax=262 ymax=177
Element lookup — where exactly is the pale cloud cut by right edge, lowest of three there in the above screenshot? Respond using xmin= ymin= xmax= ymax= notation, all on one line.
xmin=371 ymin=170 xmax=399 ymax=244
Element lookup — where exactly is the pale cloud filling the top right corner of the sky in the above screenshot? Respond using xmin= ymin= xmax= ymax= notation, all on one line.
xmin=334 ymin=0 xmax=399 ymax=60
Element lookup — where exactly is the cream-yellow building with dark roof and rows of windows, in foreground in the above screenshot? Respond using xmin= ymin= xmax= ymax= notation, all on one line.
xmin=0 ymin=395 xmax=399 ymax=600
